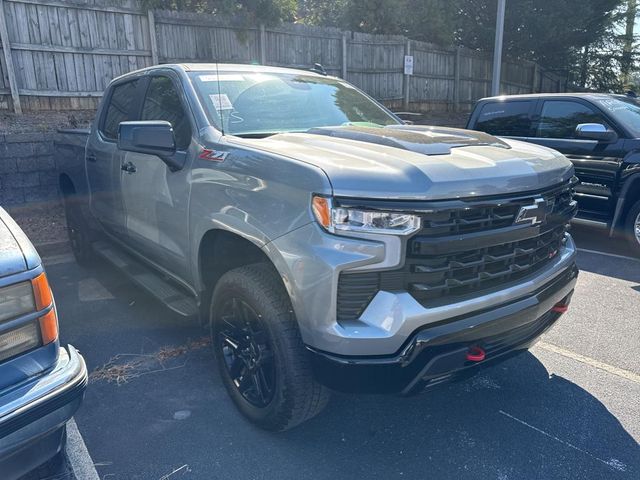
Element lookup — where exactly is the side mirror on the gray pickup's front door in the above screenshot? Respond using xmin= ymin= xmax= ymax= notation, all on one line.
xmin=118 ymin=120 xmax=182 ymax=170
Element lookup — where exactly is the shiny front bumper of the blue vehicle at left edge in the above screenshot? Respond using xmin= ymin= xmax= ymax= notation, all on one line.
xmin=0 ymin=346 xmax=87 ymax=479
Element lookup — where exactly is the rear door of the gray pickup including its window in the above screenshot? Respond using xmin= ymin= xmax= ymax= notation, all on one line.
xmin=85 ymin=79 xmax=142 ymax=236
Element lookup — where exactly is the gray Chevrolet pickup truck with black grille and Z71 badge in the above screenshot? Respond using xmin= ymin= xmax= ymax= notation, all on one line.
xmin=57 ymin=64 xmax=578 ymax=430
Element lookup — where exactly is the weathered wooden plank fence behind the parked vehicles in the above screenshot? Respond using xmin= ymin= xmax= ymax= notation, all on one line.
xmin=0 ymin=0 xmax=566 ymax=112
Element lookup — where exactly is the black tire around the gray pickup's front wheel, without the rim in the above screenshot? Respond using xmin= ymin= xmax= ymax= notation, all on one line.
xmin=209 ymin=264 xmax=330 ymax=431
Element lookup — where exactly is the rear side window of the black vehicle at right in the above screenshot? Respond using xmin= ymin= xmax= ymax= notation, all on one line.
xmin=474 ymin=101 xmax=531 ymax=137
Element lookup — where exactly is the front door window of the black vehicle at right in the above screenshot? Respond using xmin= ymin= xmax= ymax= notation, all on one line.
xmin=536 ymin=100 xmax=608 ymax=138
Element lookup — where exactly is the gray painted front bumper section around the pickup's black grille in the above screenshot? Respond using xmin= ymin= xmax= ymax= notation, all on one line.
xmin=265 ymin=219 xmax=577 ymax=356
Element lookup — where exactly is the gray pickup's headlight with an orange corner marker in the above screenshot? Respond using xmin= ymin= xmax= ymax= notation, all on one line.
xmin=312 ymin=196 xmax=420 ymax=235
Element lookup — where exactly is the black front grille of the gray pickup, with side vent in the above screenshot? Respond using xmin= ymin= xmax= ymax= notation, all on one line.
xmin=337 ymin=180 xmax=576 ymax=321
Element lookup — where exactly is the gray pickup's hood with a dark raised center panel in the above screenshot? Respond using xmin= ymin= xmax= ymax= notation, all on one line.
xmin=233 ymin=125 xmax=573 ymax=200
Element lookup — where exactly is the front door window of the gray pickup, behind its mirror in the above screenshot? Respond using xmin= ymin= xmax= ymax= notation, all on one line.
xmin=142 ymin=77 xmax=191 ymax=150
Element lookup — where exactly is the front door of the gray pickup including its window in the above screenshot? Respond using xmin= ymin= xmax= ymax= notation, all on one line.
xmin=119 ymin=73 xmax=194 ymax=279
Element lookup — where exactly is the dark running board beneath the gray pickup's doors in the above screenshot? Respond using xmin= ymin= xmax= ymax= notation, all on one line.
xmin=92 ymin=242 xmax=198 ymax=317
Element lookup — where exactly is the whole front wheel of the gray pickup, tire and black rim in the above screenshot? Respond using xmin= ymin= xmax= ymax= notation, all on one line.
xmin=209 ymin=264 xmax=329 ymax=431
